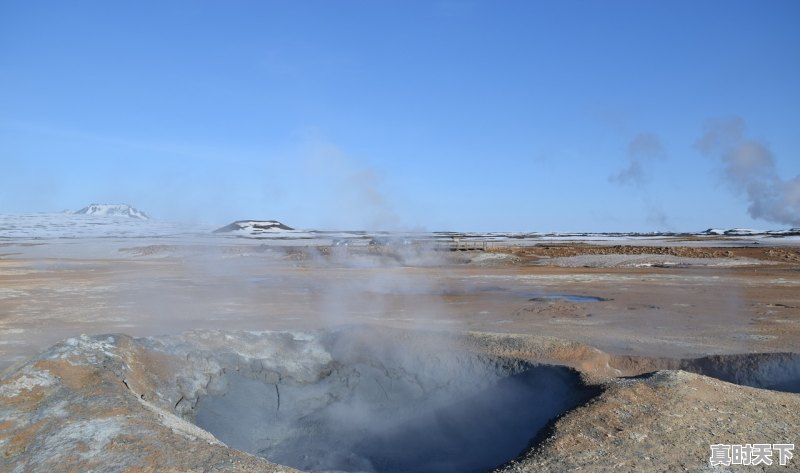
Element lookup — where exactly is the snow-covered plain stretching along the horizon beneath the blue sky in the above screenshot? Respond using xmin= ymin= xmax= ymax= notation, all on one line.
xmin=0 ymin=213 xmax=800 ymax=253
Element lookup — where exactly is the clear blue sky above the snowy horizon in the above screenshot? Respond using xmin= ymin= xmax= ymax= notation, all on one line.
xmin=0 ymin=0 xmax=800 ymax=231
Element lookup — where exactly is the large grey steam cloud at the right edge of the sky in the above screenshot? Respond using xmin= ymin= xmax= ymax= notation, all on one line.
xmin=694 ymin=117 xmax=800 ymax=226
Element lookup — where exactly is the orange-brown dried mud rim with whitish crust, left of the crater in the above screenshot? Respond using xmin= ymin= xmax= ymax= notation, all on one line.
xmin=0 ymin=336 xmax=296 ymax=473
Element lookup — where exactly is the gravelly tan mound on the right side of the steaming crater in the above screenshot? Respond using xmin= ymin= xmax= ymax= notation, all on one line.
xmin=496 ymin=371 xmax=800 ymax=473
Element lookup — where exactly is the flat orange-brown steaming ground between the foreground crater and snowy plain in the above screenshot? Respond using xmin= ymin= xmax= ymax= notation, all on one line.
xmin=0 ymin=245 xmax=800 ymax=369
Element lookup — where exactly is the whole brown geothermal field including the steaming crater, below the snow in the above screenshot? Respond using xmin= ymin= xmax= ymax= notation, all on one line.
xmin=0 ymin=241 xmax=800 ymax=472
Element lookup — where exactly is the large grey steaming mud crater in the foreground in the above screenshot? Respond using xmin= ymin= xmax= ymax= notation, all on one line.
xmin=160 ymin=331 xmax=588 ymax=473
